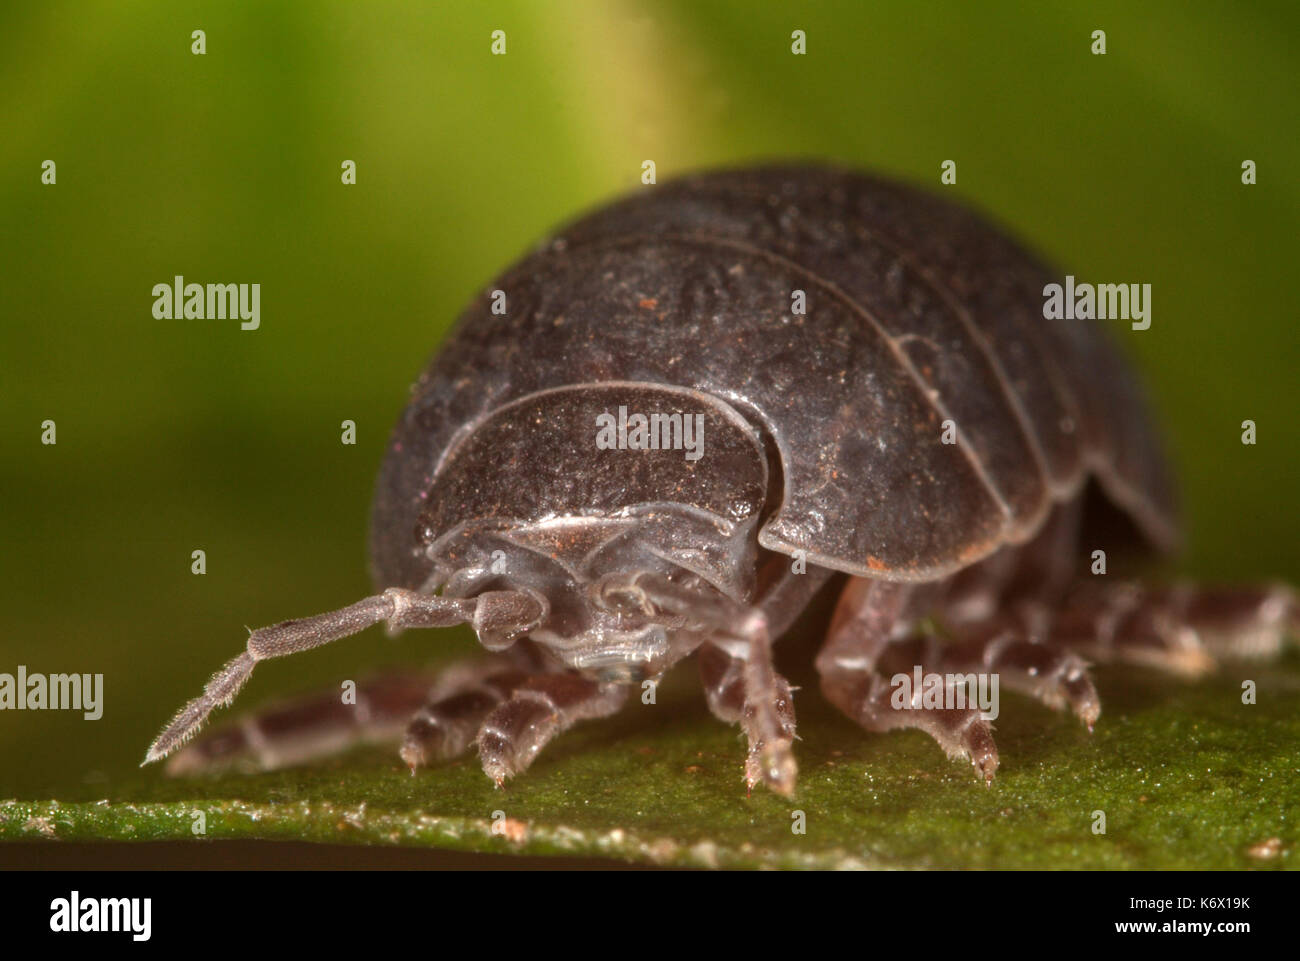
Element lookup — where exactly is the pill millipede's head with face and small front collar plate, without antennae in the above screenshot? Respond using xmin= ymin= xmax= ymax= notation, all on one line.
xmin=413 ymin=382 xmax=768 ymax=681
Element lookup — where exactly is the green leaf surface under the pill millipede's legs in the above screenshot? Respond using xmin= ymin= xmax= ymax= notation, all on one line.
xmin=0 ymin=665 xmax=1300 ymax=869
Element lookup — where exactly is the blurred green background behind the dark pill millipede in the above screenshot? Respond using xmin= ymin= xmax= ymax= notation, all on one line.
xmin=0 ymin=0 xmax=1300 ymax=797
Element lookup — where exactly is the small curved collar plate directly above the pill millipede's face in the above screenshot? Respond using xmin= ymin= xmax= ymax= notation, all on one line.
xmin=420 ymin=381 xmax=767 ymax=542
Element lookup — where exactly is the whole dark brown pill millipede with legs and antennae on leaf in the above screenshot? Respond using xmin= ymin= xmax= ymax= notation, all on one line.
xmin=139 ymin=168 xmax=1296 ymax=793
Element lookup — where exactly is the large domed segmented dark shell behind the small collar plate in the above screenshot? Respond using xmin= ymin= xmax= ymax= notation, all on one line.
xmin=372 ymin=166 xmax=1177 ymax=585
